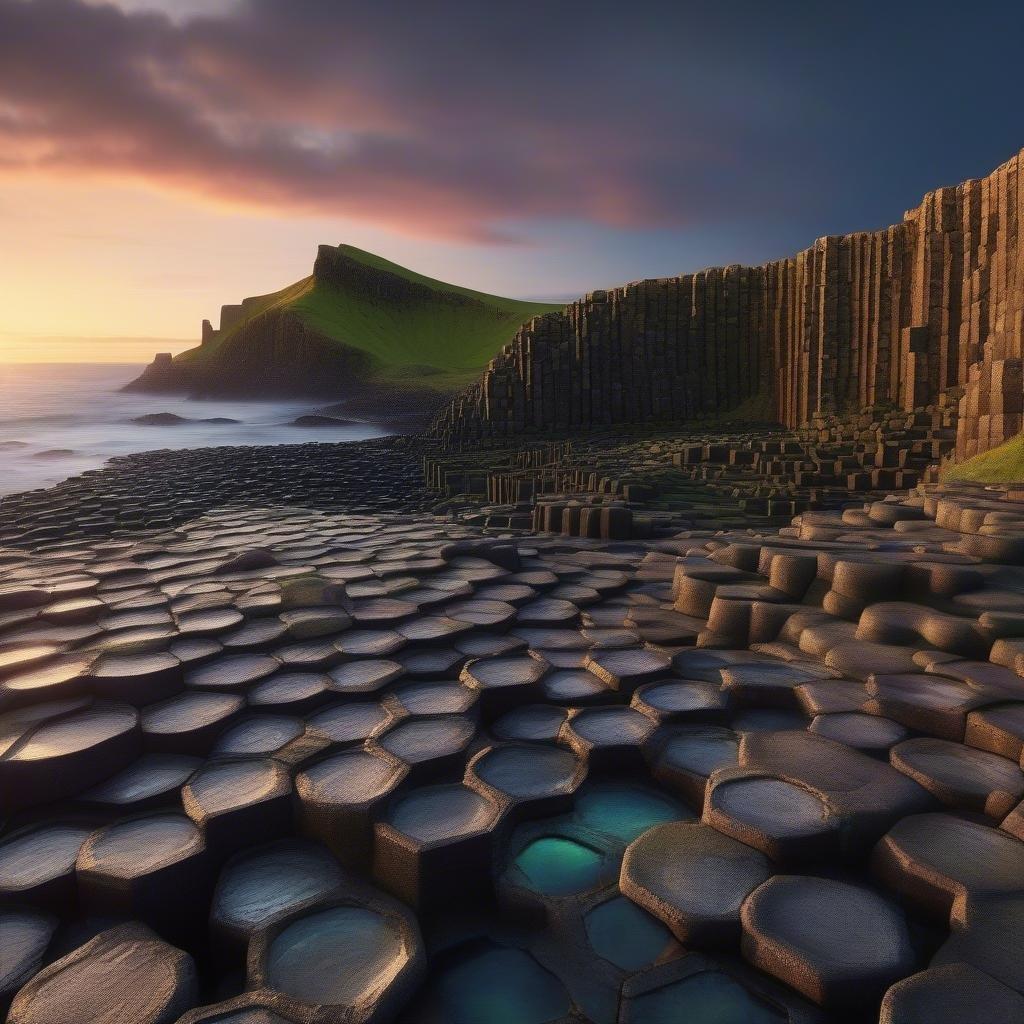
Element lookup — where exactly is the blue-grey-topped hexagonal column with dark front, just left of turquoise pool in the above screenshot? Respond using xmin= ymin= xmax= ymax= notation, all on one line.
xmin=374 ymin=784 xmax=502 ymax=911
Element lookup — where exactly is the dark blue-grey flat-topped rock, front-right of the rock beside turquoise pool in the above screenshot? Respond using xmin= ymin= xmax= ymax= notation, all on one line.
xmin=740 ymin=874 xmax=918 ymax=1008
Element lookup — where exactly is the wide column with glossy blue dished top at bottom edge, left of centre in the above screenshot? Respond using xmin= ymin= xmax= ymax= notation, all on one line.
xmin=249 ymin=886 xmax=426 ymax=1024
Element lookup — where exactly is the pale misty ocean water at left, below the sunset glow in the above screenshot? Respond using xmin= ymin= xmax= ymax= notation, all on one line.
xmin=0 ymin=364 xmax=386 ymax=495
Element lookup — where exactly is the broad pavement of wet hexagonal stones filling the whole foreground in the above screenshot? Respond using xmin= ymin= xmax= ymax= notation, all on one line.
xmin=6 ymin=468 xmax=1024 ymax=1024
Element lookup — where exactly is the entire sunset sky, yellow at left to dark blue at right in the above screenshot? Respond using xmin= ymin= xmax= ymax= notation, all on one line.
xmin=0 ymin=0 xmax=1024 ymax=361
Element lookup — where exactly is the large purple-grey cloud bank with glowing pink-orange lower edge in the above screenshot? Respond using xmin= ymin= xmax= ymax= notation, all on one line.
xmin=0 ymin=0 xmax=819 ymax=242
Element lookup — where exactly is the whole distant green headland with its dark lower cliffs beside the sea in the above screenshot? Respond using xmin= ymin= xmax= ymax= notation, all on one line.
xmin=128 ymin=246 xmax=558 ymax=397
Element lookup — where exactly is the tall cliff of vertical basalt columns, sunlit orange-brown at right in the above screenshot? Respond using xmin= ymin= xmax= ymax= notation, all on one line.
xmin=431 ymin=152 xmax=1024 ymax=464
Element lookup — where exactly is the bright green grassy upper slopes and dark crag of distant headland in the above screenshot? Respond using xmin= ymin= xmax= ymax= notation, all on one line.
xmin=175 ymin=246 xmax=561 ymax=387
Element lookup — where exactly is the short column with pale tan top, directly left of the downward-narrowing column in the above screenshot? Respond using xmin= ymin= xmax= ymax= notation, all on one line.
xmin=181 ymin=759 xmax=292 ymax=858
